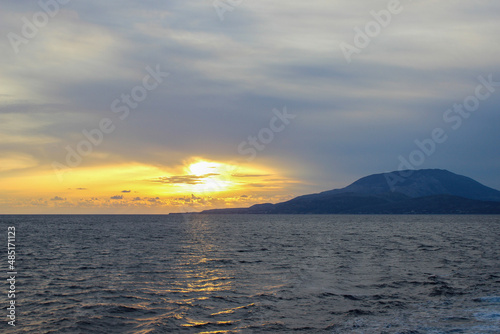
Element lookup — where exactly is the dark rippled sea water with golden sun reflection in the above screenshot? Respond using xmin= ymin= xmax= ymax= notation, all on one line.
xmin=0 ymin=215 xmax=500 ymax=334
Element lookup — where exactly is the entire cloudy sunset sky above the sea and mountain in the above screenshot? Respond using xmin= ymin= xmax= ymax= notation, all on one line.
xmin=0 ymin=0 xmax=500 ymax=214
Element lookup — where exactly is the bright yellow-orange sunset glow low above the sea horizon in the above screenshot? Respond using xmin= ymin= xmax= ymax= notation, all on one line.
xmin=0 ymin=155 xmax=294 ymax=213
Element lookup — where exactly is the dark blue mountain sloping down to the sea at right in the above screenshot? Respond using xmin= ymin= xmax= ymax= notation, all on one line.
xmin=202 ymin=169 xmax=500 ymax=214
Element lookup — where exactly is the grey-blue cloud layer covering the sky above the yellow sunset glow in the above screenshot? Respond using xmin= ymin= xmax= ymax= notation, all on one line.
xmin=0 ymin=0 xmax=500 ymax=190
